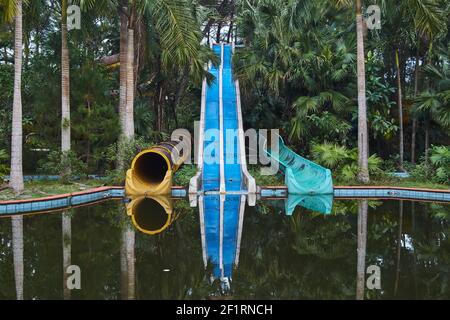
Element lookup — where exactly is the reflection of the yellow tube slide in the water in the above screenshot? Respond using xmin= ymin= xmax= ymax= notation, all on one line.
xmin=127 ymin=196 xmax=175 ymax=235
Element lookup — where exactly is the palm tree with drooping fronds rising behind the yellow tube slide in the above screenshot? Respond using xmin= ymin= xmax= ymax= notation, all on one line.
xmin=80 ymin=0 xmax=204 ymax=164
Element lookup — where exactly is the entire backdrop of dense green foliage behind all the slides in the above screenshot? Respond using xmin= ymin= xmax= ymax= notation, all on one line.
xmin=0 ymin=0 xmax=450 ymax=183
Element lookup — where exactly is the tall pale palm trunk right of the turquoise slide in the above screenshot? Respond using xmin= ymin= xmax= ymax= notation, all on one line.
xmin=356 ymin=0 xmax=370 ymax=183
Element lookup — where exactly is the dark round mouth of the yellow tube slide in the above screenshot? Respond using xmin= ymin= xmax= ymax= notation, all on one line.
xmin=133 ymin=152 xmax=169 ymax=185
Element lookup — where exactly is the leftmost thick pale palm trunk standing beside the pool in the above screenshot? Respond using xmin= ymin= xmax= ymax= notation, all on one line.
xmin=10 ymin=0 xmax=23 ymax=193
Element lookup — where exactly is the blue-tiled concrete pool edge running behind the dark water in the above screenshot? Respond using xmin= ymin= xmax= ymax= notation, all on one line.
xmin=0 ymin=186 xmax=450 ymax=216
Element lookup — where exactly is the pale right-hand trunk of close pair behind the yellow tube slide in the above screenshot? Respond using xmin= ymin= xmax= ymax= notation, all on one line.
xmin=125 ymin=29 xmax=134 ymax=139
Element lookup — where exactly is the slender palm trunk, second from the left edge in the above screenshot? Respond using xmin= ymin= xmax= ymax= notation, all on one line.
xmin=61 ymin=0 xmax=70 ymax=152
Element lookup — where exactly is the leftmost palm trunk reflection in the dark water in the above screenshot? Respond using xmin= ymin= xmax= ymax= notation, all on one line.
xmin=11 ymin=216 xmax=23 ymax=300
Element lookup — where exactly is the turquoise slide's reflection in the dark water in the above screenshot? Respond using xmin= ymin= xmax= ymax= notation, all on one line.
xmin=285 ymin=194 xmax=333 ymax=216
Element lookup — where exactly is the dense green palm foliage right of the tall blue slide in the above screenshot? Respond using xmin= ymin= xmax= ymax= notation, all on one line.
xmin=235 ymin=0 xmax=450 ymax=170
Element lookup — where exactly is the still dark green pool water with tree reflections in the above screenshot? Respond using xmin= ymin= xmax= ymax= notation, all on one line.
xmin=0 ymin=200 xmax=450 ymax=299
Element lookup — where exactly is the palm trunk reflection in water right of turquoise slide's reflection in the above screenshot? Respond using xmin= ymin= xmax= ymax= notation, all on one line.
xmin=356 ymin=200 xmax=369 ymax=300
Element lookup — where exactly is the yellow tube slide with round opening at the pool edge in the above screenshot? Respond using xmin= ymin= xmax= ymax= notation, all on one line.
xmin=125 ymin=141 xmax=188 ymax=196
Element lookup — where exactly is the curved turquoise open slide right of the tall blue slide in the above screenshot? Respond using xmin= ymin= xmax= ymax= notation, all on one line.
xmin=266 ymin=137 xmax=333 ymax=194
